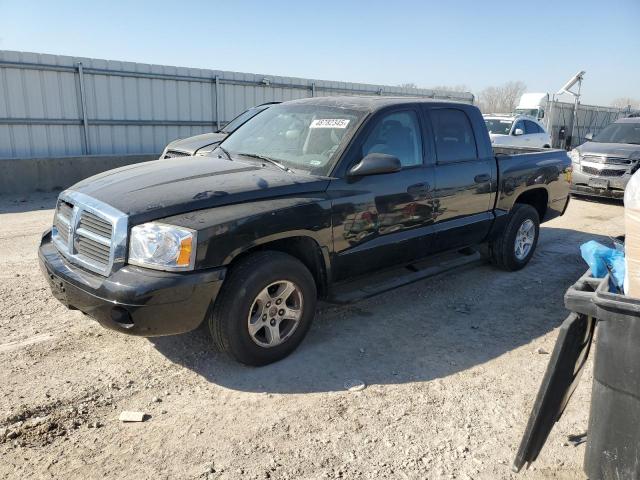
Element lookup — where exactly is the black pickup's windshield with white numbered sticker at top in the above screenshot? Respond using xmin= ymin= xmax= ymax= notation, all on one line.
xmin=221 ymin=104 xmax=366 ymax=175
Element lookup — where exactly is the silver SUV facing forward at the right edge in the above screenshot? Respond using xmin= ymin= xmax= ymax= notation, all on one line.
xmin=569 ymin=117 xmax=640 ymax=198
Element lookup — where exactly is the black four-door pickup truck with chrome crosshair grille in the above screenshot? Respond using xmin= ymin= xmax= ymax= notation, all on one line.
xmin=39 ymin=97 xmax=571 ymax=365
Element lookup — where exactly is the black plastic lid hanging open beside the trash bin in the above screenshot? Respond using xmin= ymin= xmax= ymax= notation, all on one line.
xmin=512 ymin=313 xmax=596 ymax=472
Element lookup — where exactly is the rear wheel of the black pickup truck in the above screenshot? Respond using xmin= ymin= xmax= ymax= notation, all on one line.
xmin=490 ymin=203 xmax=540 ymax=271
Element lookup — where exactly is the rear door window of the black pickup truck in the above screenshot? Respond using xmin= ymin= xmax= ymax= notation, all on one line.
xmin=430 ymin=108 xmax=478 ymax=163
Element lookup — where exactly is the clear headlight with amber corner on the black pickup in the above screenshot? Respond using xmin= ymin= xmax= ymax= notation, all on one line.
xmin=129 ymin=223 xmax=197 ymax=271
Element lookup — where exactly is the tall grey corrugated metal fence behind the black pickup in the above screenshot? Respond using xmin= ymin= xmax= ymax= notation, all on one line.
xmin=0 ymin=50 xmax=473 ymax=158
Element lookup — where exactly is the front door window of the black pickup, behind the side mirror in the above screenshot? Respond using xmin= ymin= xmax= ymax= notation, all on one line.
xmin=362 ymin=111 xmax=422 ymax=167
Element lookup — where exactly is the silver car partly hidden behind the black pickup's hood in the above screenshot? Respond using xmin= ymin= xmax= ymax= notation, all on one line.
xmin=160 ymin=102 xmax=280 ymax=159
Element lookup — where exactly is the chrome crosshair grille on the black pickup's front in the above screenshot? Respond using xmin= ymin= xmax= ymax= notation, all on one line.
xmin=52 ymin=191 xmax=127 ymax=275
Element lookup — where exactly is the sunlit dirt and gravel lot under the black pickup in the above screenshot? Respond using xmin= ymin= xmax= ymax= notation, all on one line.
xmin=0 ymin=194 xmax=623 ymax=480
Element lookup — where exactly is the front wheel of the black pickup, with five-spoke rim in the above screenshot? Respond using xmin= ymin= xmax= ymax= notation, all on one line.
xmin=208 ymin=251 xmax=317 ymax=366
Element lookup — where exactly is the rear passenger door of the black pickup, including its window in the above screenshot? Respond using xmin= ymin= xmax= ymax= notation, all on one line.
xmin=426 ymin=107 xmax=497 ymax=250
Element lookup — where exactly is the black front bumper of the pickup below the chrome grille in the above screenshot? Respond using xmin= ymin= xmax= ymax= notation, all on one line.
xmin=38 ymin=231 xmax=226 ymax=337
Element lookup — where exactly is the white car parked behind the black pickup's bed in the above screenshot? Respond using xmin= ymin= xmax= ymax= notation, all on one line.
xmin=484 ymin=115 xmax=551 ymax=148
